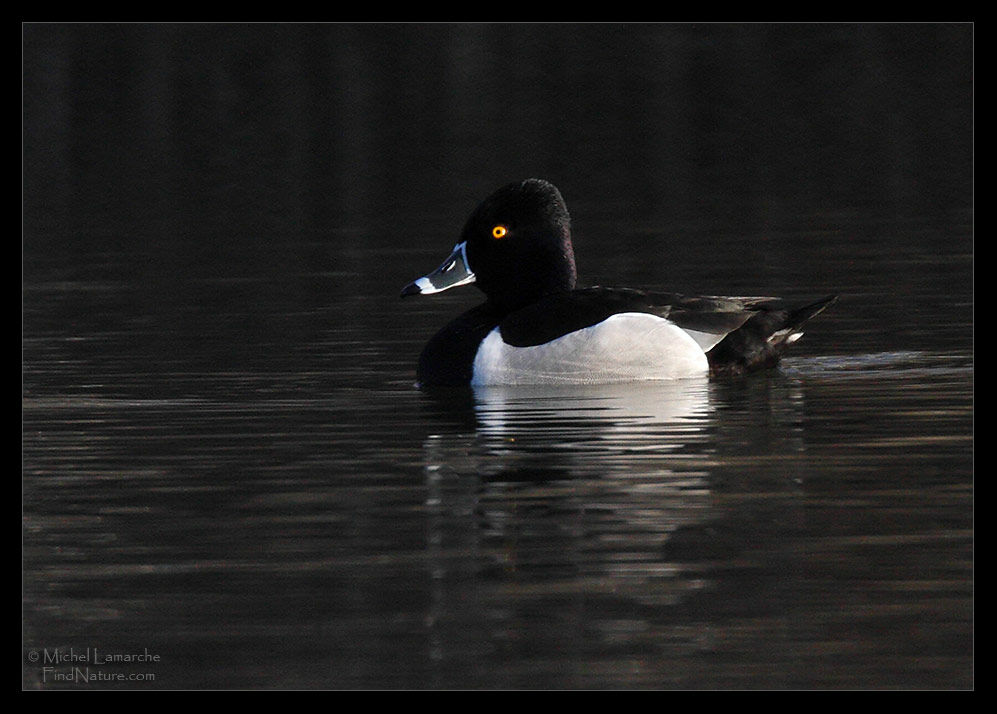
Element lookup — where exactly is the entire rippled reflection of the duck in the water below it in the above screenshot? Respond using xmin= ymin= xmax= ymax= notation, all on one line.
xmin=423 ymin=372 xmax=804 ymax=688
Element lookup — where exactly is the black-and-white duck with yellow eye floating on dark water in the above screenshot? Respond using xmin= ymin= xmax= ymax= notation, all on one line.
xmin=401 ymin=178 xmax=838 ymax=387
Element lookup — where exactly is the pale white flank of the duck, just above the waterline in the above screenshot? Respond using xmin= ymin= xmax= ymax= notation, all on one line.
xmin=471 ymin=312 xmax=709 ymax=385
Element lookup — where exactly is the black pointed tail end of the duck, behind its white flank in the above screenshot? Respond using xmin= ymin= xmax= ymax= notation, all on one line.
xmin=706 ymin=295 xmax=838 ymax=376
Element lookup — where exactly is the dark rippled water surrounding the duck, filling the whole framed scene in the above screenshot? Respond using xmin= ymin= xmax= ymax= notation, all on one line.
xmin=22 ymin=25 xmax=974 ymax=690
